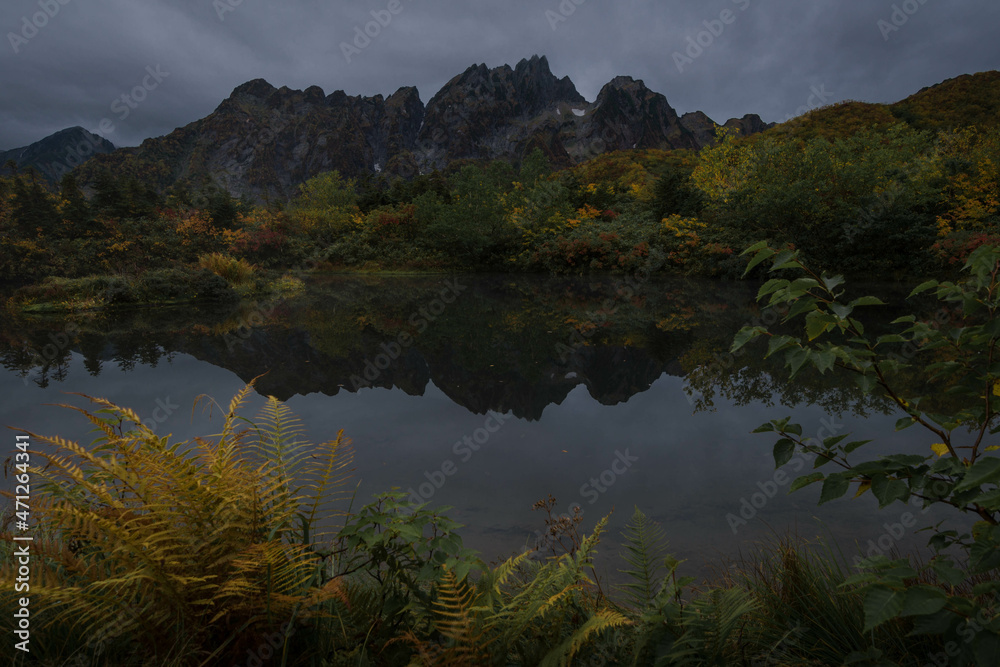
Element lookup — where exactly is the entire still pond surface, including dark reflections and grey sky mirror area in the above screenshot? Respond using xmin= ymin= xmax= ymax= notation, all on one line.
xmin=0 ymin=276 xmax=952 ymax=573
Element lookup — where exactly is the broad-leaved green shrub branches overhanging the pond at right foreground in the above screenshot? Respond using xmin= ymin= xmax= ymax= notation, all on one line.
xmin=733 ymin=243 xmax=1000 ymax=665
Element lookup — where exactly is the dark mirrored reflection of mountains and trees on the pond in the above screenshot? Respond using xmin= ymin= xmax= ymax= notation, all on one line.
xmin=0 ymin=277 xmax=920 ymax=419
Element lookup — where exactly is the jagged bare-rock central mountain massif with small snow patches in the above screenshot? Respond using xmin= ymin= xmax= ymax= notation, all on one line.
xmin=81 ymin=56 xmax=766 ymax=200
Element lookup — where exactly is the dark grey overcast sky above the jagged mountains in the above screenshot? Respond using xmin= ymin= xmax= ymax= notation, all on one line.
xmin=0 ymin=0 xmax=1000 ymax=149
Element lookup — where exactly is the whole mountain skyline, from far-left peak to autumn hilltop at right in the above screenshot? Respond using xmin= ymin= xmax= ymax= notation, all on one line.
xmin=0 ymin=56 xmax=1000 ymax=201
